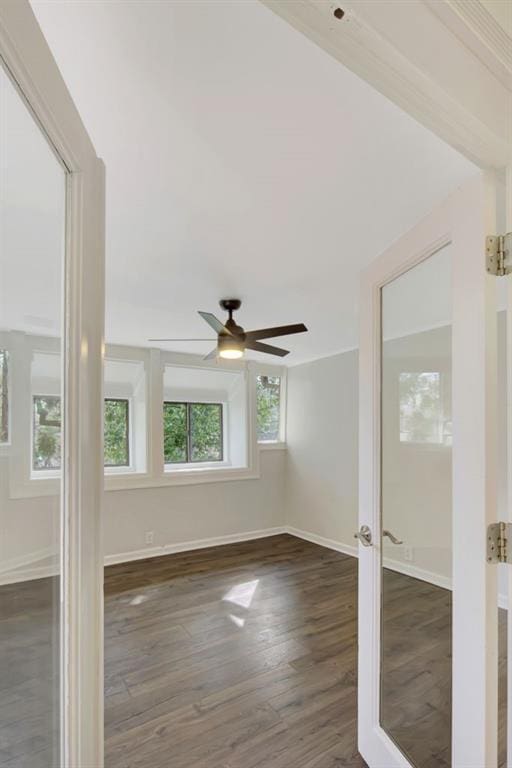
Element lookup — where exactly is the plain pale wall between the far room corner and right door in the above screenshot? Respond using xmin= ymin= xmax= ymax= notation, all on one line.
xmin=286 ymin=351 xmax=358 ymax=545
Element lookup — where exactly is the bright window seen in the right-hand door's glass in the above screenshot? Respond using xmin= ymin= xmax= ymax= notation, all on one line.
xmin=399 ymin=371 xmax=451 ymax=445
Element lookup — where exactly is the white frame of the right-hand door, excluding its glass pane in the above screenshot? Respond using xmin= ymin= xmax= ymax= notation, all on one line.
xmin=358 ymin=174 xmax=498 ymax=768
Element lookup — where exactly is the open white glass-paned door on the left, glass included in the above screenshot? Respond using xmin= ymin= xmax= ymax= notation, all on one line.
xmin=0 ymin=0 xmax=105 ymax=768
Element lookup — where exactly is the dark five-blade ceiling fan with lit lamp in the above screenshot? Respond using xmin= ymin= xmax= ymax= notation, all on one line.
xmin=149 ymin=299 xmax=307 ymax=360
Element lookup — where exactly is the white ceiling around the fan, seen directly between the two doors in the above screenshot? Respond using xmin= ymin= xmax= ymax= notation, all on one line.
xmin=27 ymin=0 xmax=476 ymax=365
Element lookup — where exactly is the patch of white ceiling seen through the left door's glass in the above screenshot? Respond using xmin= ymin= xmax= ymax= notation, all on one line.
xmin=0 ymin=67 xmax=66 ymax=336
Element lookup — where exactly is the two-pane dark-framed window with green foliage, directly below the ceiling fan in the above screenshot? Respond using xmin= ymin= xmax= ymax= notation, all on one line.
xmin=164 ymin=402 xmax=224 ymax=464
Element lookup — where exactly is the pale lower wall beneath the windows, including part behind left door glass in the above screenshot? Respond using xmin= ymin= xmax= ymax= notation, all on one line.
xmin=0 ymin=450 xmax=286 ymax=584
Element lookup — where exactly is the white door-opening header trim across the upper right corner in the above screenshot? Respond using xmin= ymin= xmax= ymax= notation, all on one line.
xmin=261 ymin=0 xmax=512 ymax=169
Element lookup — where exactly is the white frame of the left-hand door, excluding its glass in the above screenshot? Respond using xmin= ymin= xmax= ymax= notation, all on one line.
xmin=0 ymin=0 xmax=105 ymax=768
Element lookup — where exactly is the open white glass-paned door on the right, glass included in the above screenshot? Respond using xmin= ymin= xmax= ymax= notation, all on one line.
xmin=358 ymin=174 xmax=498 ymax=768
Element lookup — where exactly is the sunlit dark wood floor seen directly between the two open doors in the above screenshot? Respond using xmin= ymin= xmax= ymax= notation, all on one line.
xmin=105 ymin=536 xmax=363 ymax=768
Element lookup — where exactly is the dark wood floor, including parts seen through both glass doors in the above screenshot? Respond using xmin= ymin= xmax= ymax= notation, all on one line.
xmin=0 ymin=536 xmax=504 ymax=768
